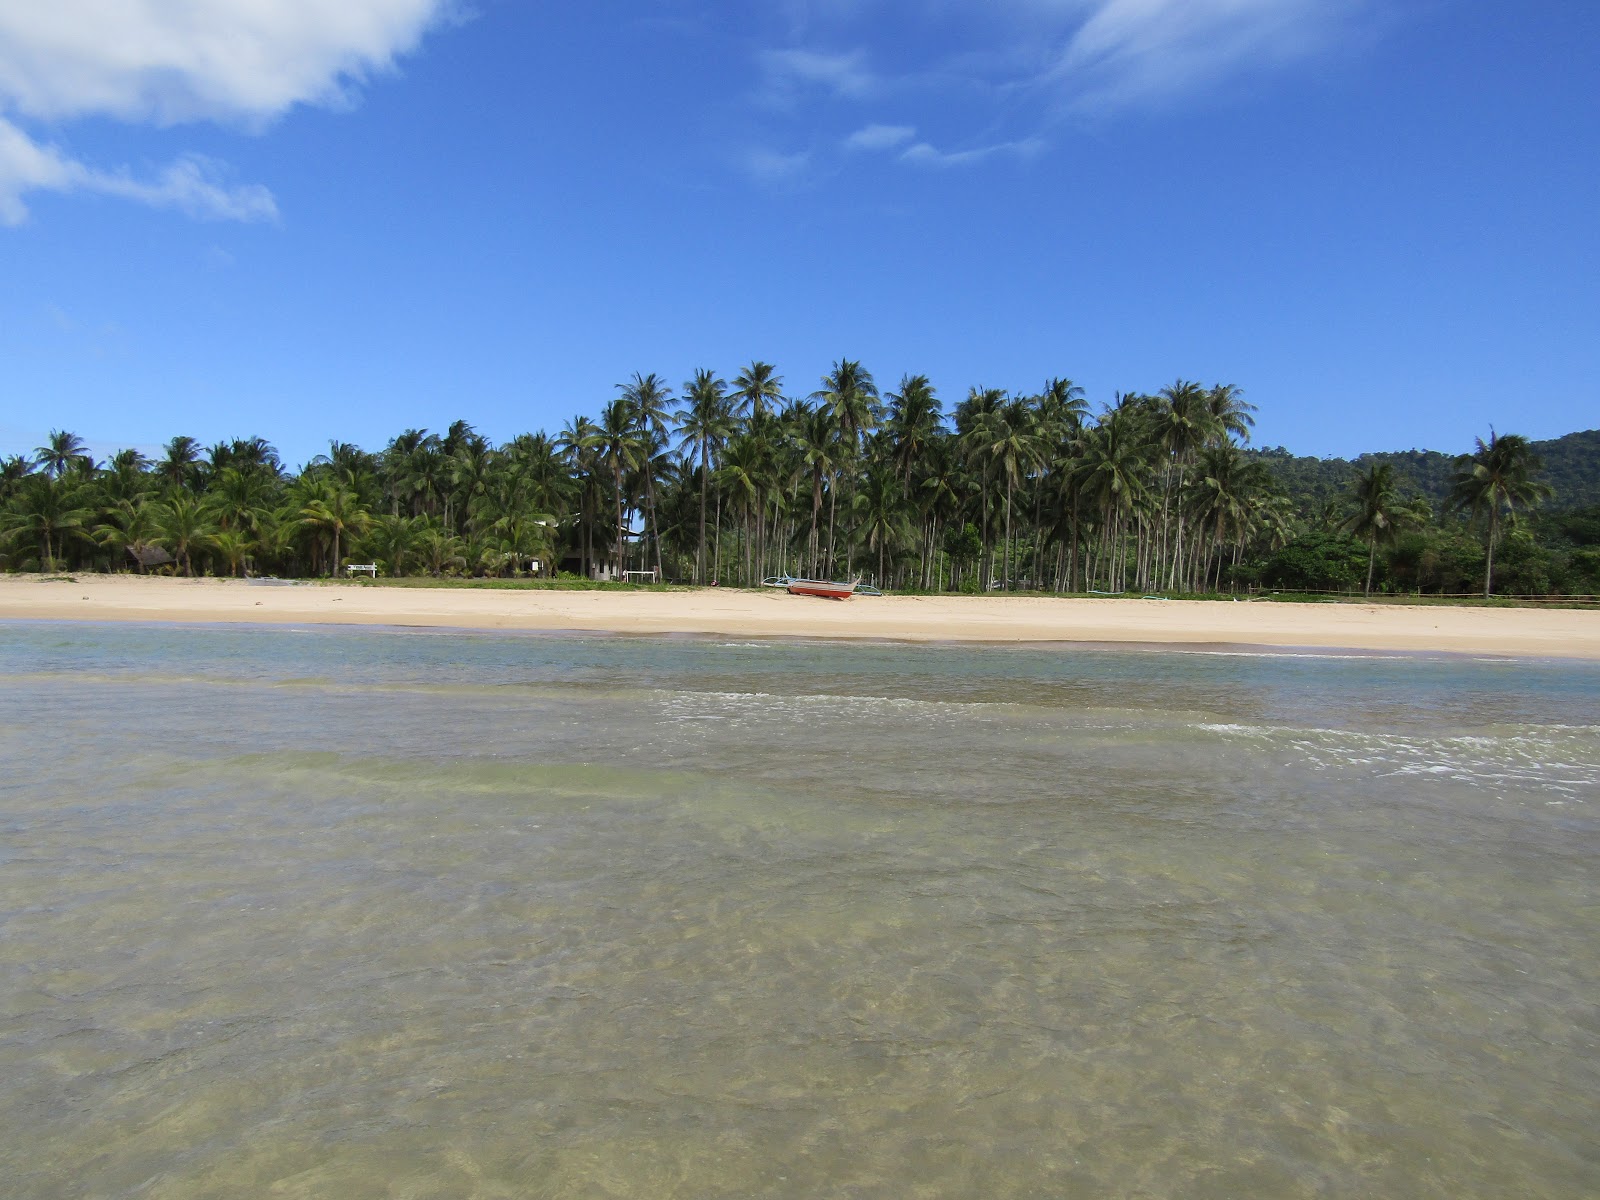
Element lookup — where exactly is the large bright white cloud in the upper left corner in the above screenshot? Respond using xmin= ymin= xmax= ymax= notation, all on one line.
xmin=0 ymin=0 xmax=450 ymax=224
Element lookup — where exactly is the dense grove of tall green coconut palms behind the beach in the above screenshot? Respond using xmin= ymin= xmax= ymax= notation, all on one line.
xmin=0 ymin=360 xmax=1600 ymax=594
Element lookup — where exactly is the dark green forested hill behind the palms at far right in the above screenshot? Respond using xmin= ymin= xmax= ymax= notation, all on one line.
xmin=1250 ymin=429 xmax=1600 ymax=512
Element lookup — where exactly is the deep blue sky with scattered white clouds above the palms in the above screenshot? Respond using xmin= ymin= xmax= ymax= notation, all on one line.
xmin=0 ymin=0 xmax=1600 ymax=464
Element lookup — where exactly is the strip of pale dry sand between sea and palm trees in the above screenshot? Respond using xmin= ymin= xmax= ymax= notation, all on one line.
xmin=0 ymin=574 xmax=1600 ymax=659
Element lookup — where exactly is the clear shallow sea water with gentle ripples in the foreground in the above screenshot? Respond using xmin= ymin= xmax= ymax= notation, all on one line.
xmin=0 ymin=622 xmax=1600 ymax=1200
